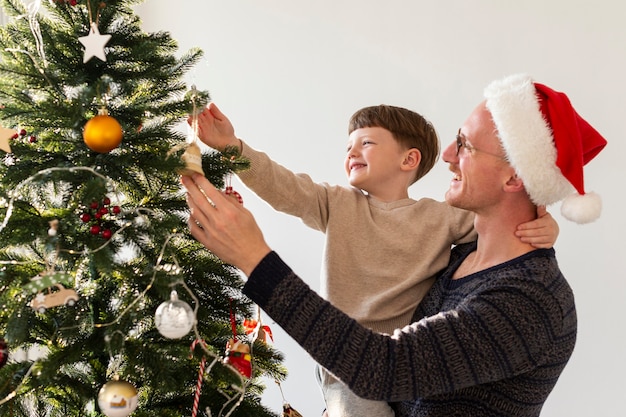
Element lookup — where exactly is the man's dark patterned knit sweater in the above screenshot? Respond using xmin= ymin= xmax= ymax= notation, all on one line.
xmin=244 ymin=244 xmax=577 ymax=417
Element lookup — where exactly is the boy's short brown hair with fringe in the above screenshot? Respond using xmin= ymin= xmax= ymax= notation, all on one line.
xmin=348 ymin=104 xmax=439 ymax=183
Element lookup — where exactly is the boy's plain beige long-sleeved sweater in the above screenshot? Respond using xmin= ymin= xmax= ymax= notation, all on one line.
xmin=239 ymin=142 xmax=476 ymax=333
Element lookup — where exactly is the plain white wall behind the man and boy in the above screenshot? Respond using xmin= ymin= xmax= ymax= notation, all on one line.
xmin=138 ymin=0 xmax=626 ymax=417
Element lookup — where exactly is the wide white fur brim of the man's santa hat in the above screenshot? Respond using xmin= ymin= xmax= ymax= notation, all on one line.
xmin=484 ymin=74 xmax=576 ymax=205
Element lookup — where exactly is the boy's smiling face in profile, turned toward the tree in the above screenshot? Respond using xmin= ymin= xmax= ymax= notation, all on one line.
xmin=344 ymin=127 xmax=406 ymax=200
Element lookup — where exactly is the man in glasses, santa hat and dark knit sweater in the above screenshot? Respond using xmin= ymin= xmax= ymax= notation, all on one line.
xmin=183 ymin=75 xmax=606 ymax=417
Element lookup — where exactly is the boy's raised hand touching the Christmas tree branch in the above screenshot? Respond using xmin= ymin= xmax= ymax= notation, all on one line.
xmin=187 ymin=103 xmax=241 ymax=151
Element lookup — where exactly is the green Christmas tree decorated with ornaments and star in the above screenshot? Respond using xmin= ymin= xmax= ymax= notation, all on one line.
xmin=0 ymin=0 xmax=285 ymax=417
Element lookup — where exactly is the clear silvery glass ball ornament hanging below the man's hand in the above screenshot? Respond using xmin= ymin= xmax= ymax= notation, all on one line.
xmin=154 ymin=290 xmax=196 ymax=339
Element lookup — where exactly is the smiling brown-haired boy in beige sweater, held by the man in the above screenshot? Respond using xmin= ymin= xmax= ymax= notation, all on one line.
xmin=188 ymin=103 xmax=558 ymax=417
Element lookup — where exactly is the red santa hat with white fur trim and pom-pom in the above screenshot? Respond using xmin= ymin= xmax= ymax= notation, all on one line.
xmin=485 ymin=74 xmax=606 ymax=224
